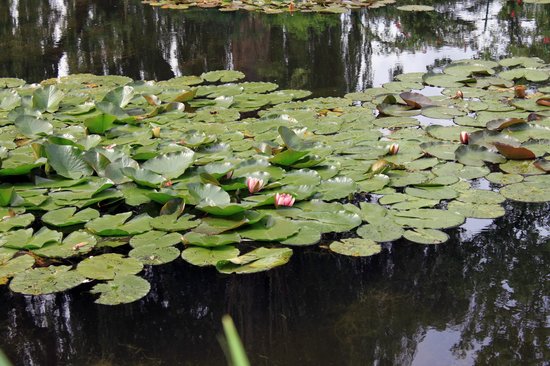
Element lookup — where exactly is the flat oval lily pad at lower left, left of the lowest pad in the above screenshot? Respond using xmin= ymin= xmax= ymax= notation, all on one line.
xmin=10 ymin=266 xmax=86 ymax=295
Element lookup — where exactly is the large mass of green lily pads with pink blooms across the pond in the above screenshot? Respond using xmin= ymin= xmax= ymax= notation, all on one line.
xmin=0 ymin=58 xmax=550 ymax=304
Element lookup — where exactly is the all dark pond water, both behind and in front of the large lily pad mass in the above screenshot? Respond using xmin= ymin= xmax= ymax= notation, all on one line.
xmin=0 ymin=0 xmax=550 ymax=365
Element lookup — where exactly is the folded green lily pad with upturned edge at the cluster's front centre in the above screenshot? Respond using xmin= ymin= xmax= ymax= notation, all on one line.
xmin=216 ymin=247 xmax=292 ymax=274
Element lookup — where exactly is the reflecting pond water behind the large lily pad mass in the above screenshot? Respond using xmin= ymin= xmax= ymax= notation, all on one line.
xmin=0 ymin=0 xmax=550 ymax=96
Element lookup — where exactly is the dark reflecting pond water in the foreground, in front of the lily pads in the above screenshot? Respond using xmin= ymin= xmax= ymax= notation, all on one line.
xmin=0 ymin=204 xmax=550 ymax=365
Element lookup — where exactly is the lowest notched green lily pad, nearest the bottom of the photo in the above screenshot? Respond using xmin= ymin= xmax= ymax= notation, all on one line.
xmin=90 ymin=275 xmax=151 ymax=305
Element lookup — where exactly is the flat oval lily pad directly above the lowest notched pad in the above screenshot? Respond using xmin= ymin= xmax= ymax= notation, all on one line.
xmin=76 ymin=253 xmax=143 ymax=280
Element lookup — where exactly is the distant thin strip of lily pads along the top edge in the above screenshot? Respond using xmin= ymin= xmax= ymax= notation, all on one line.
xmin=143 ymin=0 xmax=434 ymax=14
